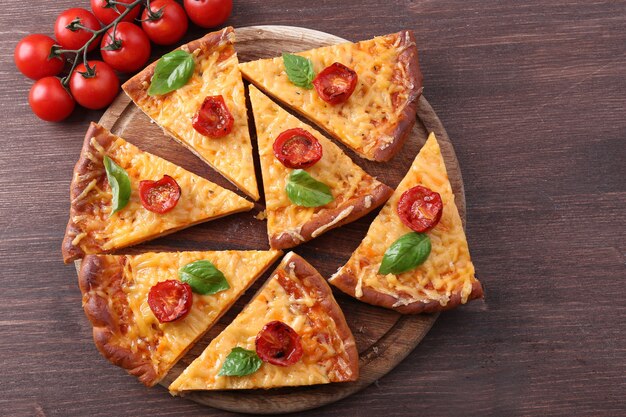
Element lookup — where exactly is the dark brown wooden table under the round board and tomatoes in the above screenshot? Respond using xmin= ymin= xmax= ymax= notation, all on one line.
xmin=0 ymin=0 xmax=626 ymax=416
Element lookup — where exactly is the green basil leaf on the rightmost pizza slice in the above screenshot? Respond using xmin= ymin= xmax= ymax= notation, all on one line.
xmin=378 ymin=232 xmax=431 ymax=275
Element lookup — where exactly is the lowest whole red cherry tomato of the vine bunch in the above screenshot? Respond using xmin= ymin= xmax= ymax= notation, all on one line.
xmin=28 ymin=77 xmax=75 ymax=122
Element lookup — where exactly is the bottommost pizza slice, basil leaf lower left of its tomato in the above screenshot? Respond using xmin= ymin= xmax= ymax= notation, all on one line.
xmin=169 ymin=252 xmax=359 ymax=394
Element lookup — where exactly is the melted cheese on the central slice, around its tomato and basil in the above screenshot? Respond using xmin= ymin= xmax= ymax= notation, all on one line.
xmin=250 ymin=85 xmax=380 ymax=245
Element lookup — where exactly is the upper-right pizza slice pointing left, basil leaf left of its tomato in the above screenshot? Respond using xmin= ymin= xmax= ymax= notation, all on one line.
xmin=239 ymin=31 xmax=422 ymax=161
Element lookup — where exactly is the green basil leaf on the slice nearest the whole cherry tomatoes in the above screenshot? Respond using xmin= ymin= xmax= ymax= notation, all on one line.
xmin=148 ymin=50 xmax=196 ymax=96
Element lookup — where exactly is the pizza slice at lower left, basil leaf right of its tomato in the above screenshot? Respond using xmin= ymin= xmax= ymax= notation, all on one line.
xmin=78 ymin=250 xmax=280 ymax=386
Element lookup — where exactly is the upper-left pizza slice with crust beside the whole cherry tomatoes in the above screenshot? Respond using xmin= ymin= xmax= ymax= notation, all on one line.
xmin=122 ymin=27 xmax=259 ymax=200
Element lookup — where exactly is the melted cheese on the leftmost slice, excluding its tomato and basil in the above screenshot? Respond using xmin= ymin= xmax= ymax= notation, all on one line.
xmin=72 ymin=128 xmax=253 ymax=254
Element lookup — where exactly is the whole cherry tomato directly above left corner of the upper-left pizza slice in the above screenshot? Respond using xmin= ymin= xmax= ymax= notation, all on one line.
xmin=100 ymin=22 xmax=150 ymax=72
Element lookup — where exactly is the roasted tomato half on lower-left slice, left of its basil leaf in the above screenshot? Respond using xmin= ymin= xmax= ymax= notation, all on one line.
xmin=148 ymin=279 xmax=193 ymax=323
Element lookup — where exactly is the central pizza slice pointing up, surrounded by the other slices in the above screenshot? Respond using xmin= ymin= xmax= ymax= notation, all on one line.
xmin=249 ymin=85 xmax=393 ymax=249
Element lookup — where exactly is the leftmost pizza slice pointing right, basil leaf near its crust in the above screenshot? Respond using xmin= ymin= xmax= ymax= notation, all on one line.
xmin=62 ymin=123 xmax=254 ymax=263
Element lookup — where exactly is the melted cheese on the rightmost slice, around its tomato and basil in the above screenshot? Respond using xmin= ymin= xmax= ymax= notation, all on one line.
xmin=329 ymin=133 xmax=476 ymax=306
